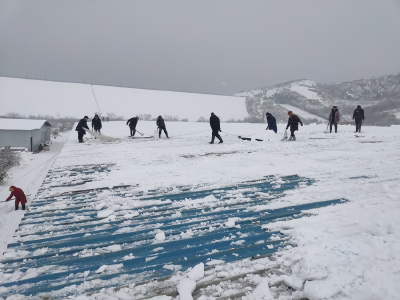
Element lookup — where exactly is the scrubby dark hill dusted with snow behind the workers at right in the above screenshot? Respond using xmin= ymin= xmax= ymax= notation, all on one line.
xmin=235 ymin=73 xmax=400 ymax=126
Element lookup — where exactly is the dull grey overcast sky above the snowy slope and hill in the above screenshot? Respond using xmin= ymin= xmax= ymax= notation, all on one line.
xmin=0 ymin=0 xmax=400 ymax=94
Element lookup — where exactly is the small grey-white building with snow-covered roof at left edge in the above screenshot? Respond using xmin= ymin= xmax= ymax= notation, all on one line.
xmin=0 ymin=119 xmax=51 ymax=152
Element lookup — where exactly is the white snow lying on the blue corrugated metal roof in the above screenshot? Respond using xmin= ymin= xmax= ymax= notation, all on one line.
xmin=0 ymin=122 xmax=400 ymax=300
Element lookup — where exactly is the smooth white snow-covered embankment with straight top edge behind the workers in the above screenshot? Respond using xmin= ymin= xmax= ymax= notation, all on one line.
xmin=0 ymin=77 xmax=248 ymax=121
